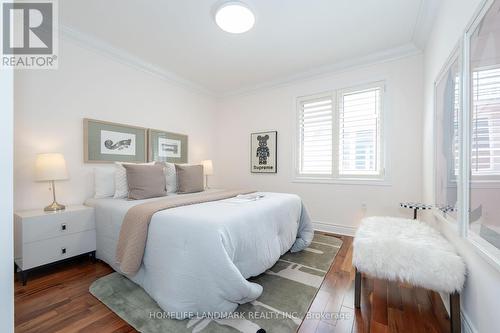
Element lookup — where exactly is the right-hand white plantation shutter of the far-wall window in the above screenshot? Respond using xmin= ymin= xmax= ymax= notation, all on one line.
xmin=339 ymin=86 xmax=383 ymax=176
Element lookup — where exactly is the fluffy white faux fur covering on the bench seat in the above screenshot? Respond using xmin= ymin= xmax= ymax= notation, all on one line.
xmin=352 ymin=216 xmax=465 ymax=293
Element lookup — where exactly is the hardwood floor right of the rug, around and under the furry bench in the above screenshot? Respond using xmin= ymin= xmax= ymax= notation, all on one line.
xmin=299 ymin=236 xmax=450 ymax=333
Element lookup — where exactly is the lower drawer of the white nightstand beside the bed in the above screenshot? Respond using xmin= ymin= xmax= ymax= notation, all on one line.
xmin=22 ymin=230 xmax=96 ymax=270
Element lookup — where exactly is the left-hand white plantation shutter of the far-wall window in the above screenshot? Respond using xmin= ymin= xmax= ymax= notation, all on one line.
xmin=298 ymin=95 xmax=333 ymax=175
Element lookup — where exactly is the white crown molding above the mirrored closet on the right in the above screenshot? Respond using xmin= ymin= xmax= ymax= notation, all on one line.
xmin=412 ymin=0 xmax=442 ymax=50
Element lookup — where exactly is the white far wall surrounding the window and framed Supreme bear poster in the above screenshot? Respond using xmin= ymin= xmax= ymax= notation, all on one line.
xmin=213 ymin=55 xmax=423 ymax=230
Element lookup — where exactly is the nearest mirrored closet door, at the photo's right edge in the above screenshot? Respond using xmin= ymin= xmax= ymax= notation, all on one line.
xmin=467 ymin=0 xmax=500 ymax=253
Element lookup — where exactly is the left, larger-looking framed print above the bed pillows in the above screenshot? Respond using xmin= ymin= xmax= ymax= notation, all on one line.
xmin=83 ymin=119 xmax=147 ymax=163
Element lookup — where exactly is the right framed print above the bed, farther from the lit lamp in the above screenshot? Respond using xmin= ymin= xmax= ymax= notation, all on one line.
xmin=148 ymin=129 xmax=188 ymax=163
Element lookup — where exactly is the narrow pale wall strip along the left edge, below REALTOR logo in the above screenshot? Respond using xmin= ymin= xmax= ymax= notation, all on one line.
xmin=0 ymin=64 xmax=14 ymax=333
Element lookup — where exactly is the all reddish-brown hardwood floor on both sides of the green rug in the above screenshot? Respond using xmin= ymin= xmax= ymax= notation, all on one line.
xmin=15 ymin=236 xmax=449 ymax=333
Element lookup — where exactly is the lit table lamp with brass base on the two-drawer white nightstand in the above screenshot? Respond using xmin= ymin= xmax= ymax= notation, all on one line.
xmin=35 ymin=153 xmax=68 ymax=212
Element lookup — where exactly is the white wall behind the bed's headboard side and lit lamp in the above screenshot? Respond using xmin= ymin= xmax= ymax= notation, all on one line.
xmin=14 ymin=39 xmax=216 ymax=209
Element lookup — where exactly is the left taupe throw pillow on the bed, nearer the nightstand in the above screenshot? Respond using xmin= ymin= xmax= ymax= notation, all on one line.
xmin=123 ymin=164 xmax=167 ymax=200
